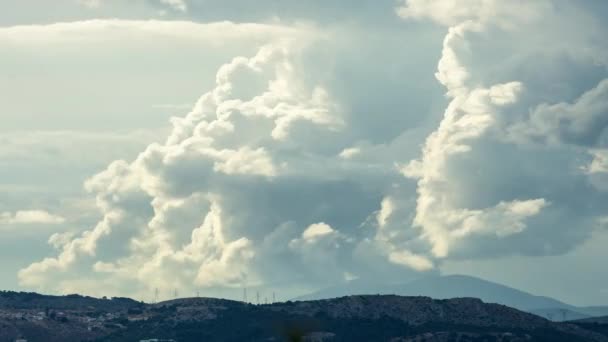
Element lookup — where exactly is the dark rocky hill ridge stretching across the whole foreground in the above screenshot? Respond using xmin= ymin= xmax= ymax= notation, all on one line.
xmin=0 ymin=293 xmax=608 ymax=342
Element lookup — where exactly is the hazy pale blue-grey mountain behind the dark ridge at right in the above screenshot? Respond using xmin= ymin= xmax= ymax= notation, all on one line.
xmin=294 ymin=275 xmax=608 ymax=320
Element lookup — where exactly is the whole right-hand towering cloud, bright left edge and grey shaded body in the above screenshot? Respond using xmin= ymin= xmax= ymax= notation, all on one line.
xmin=384 ymin=0 xmax=605 ymax=259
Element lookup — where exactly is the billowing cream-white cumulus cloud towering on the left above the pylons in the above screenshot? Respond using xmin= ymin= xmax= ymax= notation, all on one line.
xmin=20 ymin=30 xmax=354 ymax=291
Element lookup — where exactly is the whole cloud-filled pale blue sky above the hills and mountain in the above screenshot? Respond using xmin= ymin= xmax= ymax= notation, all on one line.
xmin=0 ymin=0 xmax=608 ymax=305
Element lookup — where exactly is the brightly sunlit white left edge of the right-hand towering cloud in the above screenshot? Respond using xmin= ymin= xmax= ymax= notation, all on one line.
xmin=401 ymin=7 xmax=546 ymax=258
